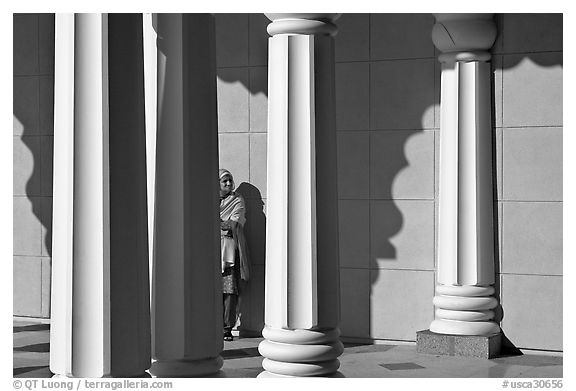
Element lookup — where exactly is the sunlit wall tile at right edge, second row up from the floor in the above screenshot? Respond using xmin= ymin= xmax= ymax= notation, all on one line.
xmin=501 ymin=202 xmax=562 ymax=275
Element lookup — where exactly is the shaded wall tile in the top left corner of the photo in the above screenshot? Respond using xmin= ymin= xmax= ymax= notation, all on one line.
xmin=12 ymin=15 xmax=38 ymax=75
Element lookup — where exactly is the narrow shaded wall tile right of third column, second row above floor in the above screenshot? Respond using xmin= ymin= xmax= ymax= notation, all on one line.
xmin=338 ymin=200 xmax=370 ymax=268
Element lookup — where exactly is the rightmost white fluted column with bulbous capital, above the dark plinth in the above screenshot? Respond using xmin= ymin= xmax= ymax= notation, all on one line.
xmin=430 ymin=14 xmax=500 ymax=336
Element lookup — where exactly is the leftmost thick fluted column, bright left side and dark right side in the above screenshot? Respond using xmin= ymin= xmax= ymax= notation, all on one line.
xmin=50 ymin=14 xmax=150 ymax=377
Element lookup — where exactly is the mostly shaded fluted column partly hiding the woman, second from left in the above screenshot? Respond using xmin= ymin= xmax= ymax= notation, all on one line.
xmin=150 ymin=14 xmax=223 ymax=377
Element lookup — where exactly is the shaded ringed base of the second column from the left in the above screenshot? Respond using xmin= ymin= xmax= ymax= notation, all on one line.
xmin=150 ymin=356 xmax=224 ymax=377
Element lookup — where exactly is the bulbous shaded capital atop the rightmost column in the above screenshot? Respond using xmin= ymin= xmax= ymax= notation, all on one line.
xmin=432 ymin=14 xmax=498 ymax=61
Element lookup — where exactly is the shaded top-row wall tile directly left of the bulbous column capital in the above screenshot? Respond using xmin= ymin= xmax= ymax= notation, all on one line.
xmin=370 ymin=13 xmax=434 ymax=60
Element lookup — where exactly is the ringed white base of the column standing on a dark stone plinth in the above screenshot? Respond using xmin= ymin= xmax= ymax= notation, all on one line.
xmin=430 ymin=285 xmax=500 ymax=336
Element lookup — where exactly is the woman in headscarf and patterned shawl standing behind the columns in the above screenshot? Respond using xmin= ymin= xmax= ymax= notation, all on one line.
xmin=220 ymin=169 xmax=249 ymax=341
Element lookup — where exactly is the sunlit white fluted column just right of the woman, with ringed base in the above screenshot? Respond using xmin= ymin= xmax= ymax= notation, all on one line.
xmin=259 ymin=14 xmax=343 ymax=377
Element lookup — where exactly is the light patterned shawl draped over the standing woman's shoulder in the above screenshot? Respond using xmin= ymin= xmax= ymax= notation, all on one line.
xmin=220 ymin=192 xmax=250 ymax=281
